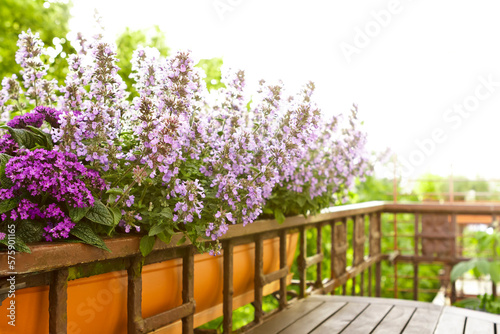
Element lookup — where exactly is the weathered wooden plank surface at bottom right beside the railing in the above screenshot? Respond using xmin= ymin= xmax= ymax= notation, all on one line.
xmin=250 ymin=296 xmax=500 ymax=334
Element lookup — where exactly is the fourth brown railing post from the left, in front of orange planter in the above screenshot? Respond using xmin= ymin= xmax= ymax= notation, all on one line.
xmin=222 ymin=240 xmax=234 ymax=333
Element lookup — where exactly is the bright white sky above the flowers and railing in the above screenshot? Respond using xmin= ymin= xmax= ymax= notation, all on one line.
xmin=71 ymin=0 xmax=500 ymax=179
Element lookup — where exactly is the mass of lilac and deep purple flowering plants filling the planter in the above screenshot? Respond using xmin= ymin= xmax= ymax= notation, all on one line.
xmin=0 ymin=32 xmax=369 ymax=255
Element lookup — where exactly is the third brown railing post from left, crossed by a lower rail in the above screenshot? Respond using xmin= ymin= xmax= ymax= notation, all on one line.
xmin=182 ymin=246 xmax=194 ymax=334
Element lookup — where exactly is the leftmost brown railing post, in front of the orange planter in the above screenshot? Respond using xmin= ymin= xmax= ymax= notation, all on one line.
xmin=49 ymin=268 xmax=68 ymax=334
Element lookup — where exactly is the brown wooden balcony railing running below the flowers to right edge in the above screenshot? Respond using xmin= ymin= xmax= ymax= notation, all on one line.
xmin=0 ymin=202 xmax=500 ymax=333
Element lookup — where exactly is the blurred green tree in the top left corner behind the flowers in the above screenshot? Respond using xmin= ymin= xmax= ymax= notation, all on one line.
xmin=0 ymin=0 xmax=74 ymax=83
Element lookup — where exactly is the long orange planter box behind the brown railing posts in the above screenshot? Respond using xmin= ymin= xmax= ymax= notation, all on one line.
xmin=0 ymin=234 xmax=298 ymax=334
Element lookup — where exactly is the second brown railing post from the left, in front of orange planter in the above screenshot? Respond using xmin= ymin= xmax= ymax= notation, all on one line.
xmin=127 ymin=256 xmax=144 ymax=334
